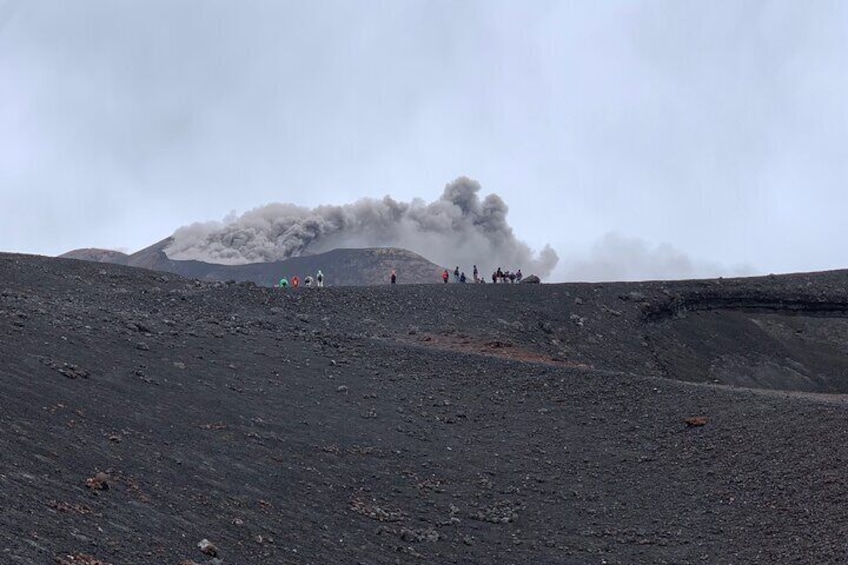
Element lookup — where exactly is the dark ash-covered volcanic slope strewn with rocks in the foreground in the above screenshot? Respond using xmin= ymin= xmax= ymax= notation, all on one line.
xmin=0 ymin=255 xmax=848 ymax=565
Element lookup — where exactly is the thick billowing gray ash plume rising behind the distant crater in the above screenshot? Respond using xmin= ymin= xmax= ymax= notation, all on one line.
xmin=166 ymin=177 xmax=559 ymax=277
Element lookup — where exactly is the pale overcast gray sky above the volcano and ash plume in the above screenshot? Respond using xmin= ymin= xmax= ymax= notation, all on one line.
xmin=0 ymin=0 xmax=848 ymax=280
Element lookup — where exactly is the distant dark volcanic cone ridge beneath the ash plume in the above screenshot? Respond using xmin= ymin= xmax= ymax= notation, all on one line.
xmin=60 ymin=237 xmax=444 ymax=286
